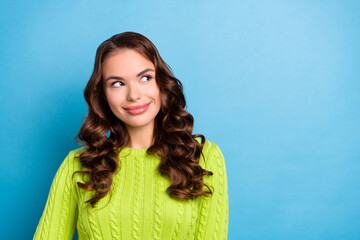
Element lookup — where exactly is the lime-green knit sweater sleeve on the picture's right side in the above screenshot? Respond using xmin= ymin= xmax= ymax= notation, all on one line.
xmin=195 ymin=141 xmax=229 ymax=240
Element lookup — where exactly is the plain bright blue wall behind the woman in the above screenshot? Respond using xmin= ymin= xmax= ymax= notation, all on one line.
xmin=0 ymin=0 xmax=360 ymax=240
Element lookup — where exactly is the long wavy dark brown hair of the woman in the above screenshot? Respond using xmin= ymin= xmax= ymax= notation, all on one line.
xmin=73 ymin=32 xmax=213 ymax=207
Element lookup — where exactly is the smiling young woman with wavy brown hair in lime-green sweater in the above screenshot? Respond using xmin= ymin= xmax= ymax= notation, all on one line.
xmin=34 ymin=32 xmax=229 ymax=240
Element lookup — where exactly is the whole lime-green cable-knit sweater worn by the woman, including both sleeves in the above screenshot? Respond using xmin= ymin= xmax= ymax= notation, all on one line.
xmin=33 ymin=138 xmax=229 ymax=240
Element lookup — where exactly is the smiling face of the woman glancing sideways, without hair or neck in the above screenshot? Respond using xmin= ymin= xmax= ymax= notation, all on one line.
xmin=102 ymin=49 xmax=161 ymax=129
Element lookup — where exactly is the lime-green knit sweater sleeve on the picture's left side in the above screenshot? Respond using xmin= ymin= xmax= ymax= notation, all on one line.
xmin=33 ymin=152 xmax=78 ymax=240
